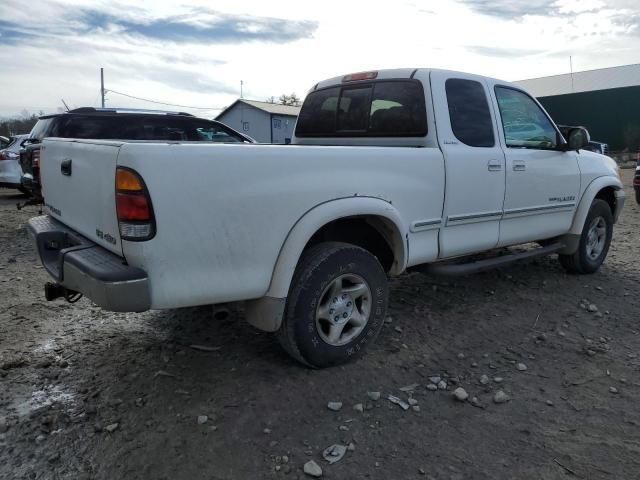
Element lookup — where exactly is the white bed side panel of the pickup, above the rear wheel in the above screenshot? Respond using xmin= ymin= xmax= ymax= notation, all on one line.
xmin=118 ymin=143 xmax=444 ymax=308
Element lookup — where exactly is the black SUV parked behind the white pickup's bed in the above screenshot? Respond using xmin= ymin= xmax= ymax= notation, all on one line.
xmin=20 ymin=107 xmax=255 ymax=200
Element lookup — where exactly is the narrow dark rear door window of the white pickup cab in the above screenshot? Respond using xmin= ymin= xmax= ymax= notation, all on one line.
xmin=445 ymin=78 xmax=495 ymax=147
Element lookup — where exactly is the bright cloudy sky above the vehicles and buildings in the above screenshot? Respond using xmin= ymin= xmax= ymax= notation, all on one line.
xmin=0 ymin=0 xmax=640 ymax=118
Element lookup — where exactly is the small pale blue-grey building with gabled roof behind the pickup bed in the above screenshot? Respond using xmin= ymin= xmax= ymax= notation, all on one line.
xmin=216 ymin=98 xmax=300 ymax=143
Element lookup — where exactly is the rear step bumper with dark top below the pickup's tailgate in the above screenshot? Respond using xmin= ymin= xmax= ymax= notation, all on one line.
xmin=28 ymin=215 xmax=151 ymax=312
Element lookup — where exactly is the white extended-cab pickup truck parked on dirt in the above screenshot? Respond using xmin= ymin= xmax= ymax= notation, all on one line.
xmin=29 ymin=69 xmax=625 ymax=367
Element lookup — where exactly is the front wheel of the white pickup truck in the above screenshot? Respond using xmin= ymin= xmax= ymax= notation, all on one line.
xmin=558 ymin=198 xmax=613 ymax=274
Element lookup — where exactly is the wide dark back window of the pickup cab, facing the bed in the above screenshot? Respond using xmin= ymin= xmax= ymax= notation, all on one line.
xmin=296 ymin=80 xmax=427 ymax=137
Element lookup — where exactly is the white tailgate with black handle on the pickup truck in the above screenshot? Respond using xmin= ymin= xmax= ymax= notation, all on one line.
xmin=40 ymin=139 xmax=122 ymax=255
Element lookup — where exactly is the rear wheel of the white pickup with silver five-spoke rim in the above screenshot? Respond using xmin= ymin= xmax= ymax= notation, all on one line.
xmin=277 ymin=242 xmax=389 ymax=368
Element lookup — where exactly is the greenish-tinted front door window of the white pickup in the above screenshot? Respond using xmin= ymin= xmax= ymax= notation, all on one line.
xmin=496 ymin=87 xmax=558 ymax=149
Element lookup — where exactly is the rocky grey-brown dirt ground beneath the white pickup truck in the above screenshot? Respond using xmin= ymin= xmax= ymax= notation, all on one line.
xmin=0 ymin=170 xmax=640 ymax=480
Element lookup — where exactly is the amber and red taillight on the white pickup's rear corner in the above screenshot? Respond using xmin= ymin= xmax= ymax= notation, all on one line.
xmin=116 ymin=167 xmax=156 ymax=241
